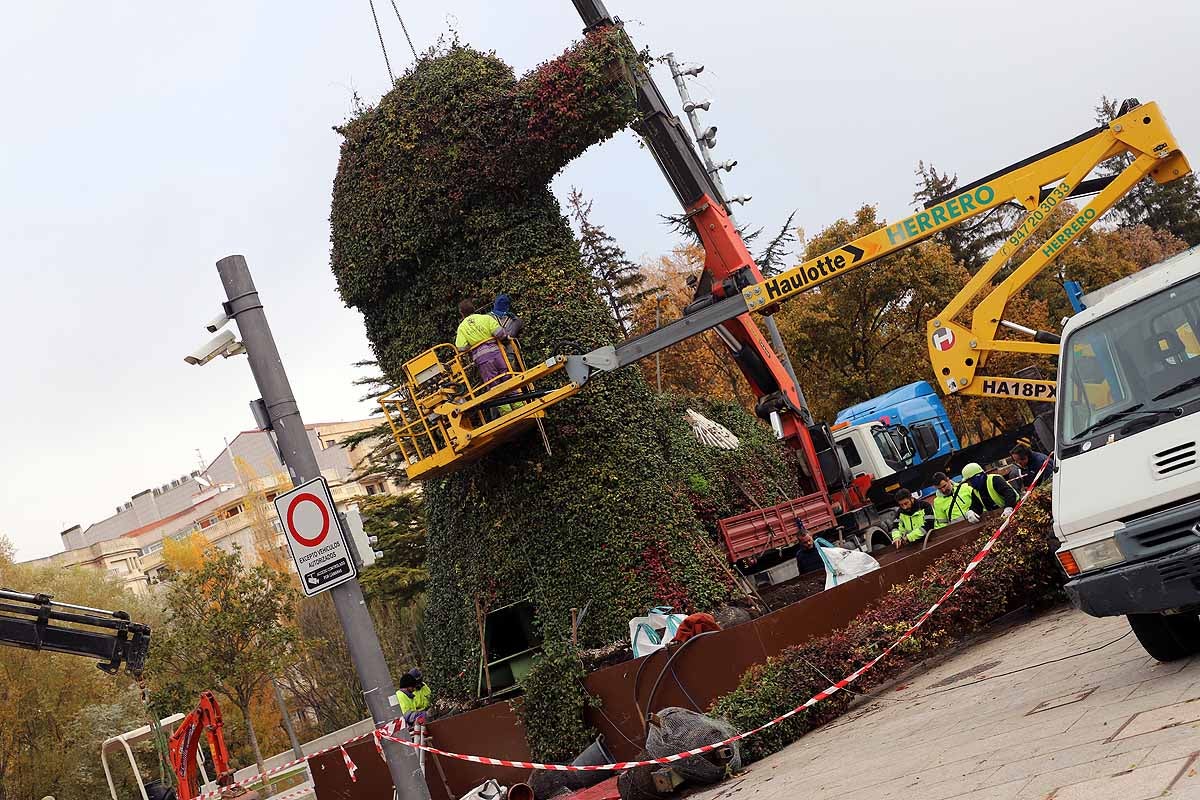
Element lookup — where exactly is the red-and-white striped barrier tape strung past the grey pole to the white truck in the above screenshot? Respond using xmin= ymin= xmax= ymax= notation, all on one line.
xmin=197 ymin=458 xmax=1050 ymax=786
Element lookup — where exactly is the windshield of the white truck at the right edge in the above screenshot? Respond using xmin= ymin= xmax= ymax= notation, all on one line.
xmin=1058 ymin=276 xmax=1200 ymax=444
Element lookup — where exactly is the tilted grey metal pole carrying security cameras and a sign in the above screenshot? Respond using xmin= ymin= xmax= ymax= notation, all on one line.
xmin=217 ymin=255 xmax=430 ymax=800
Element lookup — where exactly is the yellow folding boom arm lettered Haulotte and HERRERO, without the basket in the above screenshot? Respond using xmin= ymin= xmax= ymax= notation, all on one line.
xmin=743 ymin=101 xmax=1192 ymax=401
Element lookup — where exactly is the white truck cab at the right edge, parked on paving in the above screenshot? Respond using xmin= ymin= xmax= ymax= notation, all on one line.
xmin=1054 ymin=247 xmax=1200 ymax=661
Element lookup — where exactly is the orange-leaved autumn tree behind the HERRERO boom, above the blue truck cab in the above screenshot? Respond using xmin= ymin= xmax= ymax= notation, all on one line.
xmin=776 ymin=205 xmax=967 ymax=420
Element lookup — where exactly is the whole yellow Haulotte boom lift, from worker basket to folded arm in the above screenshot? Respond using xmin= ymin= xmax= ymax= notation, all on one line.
xmin=380 ymin=101 xmax=1190 ymax=480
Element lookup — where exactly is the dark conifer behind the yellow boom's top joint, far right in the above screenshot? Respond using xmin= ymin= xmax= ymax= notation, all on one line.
xmin=1096 ymin=96 xmax=1200 ymax=247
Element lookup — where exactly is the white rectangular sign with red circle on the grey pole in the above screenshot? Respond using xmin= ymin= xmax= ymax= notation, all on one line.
xmin=275 ymin=477 xmax=358 ymax=597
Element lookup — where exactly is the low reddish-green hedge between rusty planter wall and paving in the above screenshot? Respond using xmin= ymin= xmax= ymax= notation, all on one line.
xmin=714 ymin=491 xmax=1062 ymax=762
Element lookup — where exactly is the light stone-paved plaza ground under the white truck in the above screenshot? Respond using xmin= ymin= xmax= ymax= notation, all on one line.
xmin=692 ymin=607 xmax=1200 ymax=800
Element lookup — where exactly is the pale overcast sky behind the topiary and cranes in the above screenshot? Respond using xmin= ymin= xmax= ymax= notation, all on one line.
xmin=0 ymin=0 xmax=1200 ymax=558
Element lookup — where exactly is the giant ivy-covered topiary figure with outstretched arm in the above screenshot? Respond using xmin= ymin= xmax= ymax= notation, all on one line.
xmin=331 ymin=31 xmax=796 ymax=757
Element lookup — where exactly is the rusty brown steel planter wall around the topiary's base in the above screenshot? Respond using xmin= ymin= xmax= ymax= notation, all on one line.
xmin=308 ymin=525 xmax=982 ymax=800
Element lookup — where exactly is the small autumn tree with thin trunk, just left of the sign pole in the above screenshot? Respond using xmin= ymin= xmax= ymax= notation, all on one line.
xmin=150 ymin=548 xmax=299 ymax=770
